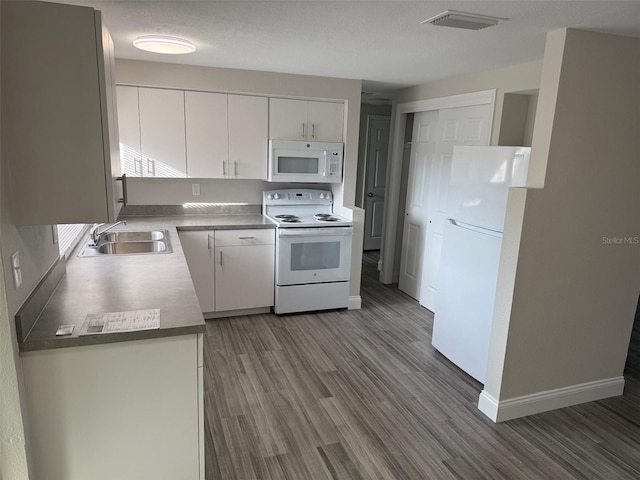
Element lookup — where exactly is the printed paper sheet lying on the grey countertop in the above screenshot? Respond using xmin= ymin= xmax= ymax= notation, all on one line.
xmin=78 ymin=308 xmax=160 ymax=335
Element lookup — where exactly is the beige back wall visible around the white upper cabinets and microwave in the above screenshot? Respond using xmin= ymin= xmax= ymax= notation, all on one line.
xmin=116 ymin=59 xmax=364 ymax=297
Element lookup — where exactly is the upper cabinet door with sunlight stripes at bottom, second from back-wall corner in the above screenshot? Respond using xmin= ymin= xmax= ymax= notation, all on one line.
xmin=138 ymin=88 xmax=187 ymax=177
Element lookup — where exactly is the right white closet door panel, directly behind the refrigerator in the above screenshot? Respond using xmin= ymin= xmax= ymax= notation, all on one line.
xmin=417 ymin=104 xmax=492 ymax=311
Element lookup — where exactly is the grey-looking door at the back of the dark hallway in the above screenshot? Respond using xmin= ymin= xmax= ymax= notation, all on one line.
xmin=364 ymin=115 xmax=391 ymax=250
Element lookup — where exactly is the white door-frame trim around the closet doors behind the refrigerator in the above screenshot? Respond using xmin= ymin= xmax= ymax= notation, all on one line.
xmin=380 ymin=89 xmax=497 ymax=284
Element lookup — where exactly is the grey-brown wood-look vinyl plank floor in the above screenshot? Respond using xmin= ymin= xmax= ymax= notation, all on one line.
xmin=204 ymin=254 xmax=640 ymax=480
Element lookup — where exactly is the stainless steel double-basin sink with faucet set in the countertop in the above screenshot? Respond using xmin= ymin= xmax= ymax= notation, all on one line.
xmin=79 ymin=230 xmax=173 ymax=257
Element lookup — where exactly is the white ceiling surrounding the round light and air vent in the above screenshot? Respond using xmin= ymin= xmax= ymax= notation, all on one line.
xmin=51 ymin=0 xmax=640 ymax=94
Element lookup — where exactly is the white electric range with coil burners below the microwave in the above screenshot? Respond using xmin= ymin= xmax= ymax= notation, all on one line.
xmin=262 ymin=189 xmax=353 ymax=313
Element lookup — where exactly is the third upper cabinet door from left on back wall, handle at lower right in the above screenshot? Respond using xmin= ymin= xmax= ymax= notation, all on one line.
xmin=184 ymin=92 xmax=229 ymax=178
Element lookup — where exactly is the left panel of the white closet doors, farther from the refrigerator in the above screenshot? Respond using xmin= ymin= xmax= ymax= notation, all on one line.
xmin=398 ymin=111 xmax=438 ymax=300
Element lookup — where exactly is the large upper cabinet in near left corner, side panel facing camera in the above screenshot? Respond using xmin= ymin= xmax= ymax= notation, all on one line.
xmin=0 ymin=2 xmax=122 ymax=225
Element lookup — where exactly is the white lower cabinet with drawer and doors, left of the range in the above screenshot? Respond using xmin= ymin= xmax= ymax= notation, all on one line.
xmin=180 ymin=229 xmax=275 ymax=318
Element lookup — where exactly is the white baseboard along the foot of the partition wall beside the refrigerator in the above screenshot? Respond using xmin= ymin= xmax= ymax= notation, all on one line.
xmin=478 ymin=377 xmax=624 ymax=422
